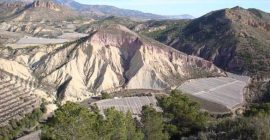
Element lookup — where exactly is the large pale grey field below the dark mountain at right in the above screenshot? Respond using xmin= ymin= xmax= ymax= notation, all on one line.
xmin=178 ymin=77 xmax=247 ymax=112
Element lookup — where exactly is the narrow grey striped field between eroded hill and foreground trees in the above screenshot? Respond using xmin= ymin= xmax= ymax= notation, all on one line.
xmin=93 ymin=96 xmax=159 ymax=116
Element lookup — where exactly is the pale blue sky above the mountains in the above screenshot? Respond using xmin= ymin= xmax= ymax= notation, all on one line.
xmin=76 ymin=0 xmax=270 ymax=17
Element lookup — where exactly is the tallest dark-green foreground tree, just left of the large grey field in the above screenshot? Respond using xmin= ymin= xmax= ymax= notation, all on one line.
xmin=159 ymin=90 xmax=208 ymax=139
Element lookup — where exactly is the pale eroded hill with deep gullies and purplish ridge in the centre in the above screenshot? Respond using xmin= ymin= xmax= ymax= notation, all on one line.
xmin=0 ymin=25 xmax=224 ymax=101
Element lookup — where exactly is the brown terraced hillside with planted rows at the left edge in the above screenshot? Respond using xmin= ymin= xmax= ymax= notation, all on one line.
xmin=0 ymin=71 xmax=40 ymax=126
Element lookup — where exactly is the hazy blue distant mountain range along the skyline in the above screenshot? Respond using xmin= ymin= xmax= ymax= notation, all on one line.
xmin=0 ymin=0 xmax=193 ymax=20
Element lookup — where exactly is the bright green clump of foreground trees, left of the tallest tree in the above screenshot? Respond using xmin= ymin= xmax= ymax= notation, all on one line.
xmin=42 ymin=102 xmax=143 ymax=140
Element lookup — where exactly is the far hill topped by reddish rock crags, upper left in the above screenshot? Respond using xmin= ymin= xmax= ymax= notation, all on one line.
xmin=2 ymin=0 xmax=79 ymax=21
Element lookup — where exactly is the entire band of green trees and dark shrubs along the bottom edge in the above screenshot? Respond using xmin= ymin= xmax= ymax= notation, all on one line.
xmin=42 ymin=91 xmax=270 ymax=140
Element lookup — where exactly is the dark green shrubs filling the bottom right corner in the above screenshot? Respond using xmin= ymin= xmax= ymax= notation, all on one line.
xmin=204 ymin=117 xmax=270 ymax=140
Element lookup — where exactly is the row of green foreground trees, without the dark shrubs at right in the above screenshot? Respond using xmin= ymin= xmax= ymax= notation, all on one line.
xmin=40 ymin=91 xmax=208 ymax=140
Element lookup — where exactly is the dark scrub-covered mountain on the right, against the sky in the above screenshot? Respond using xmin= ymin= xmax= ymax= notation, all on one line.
xmin=139 ymin=7 xmax=270 ymax=75
